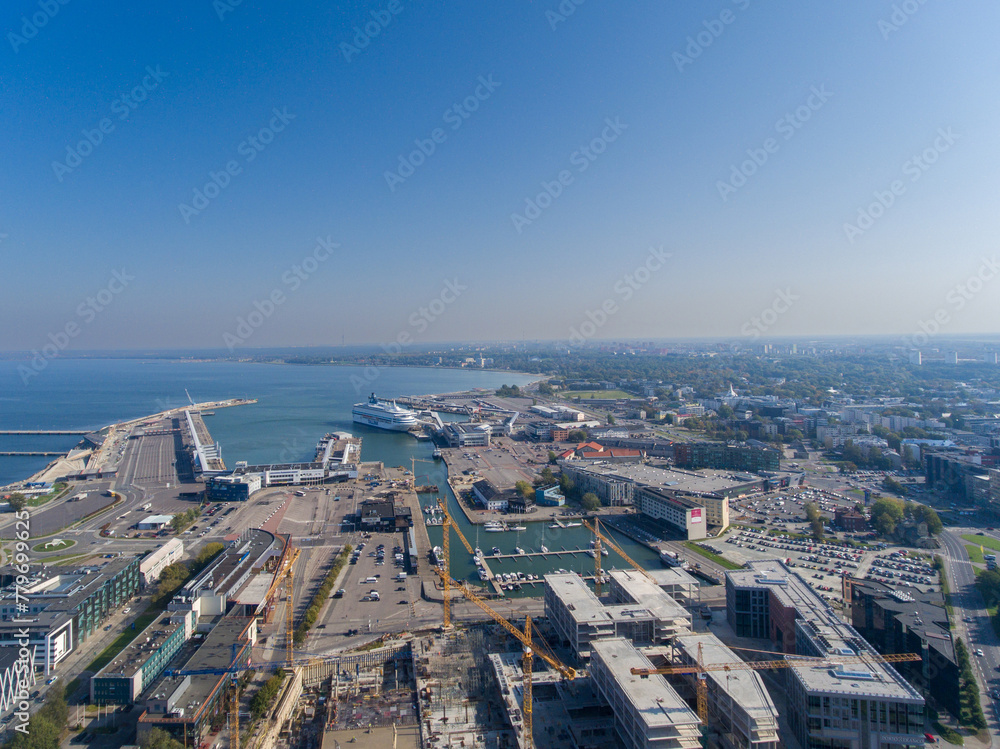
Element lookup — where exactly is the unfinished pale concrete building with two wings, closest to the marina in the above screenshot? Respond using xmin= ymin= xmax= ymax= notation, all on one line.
xmin=545 ymin=570 xmax=691 ymax=660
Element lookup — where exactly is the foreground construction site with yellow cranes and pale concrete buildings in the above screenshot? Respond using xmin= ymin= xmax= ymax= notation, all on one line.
xmin=125 ymin=486 xmax=925 ymax=749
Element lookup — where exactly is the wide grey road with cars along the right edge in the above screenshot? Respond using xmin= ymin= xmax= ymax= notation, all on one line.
xmin=941 ymin=528 xmax=1000 ymax=734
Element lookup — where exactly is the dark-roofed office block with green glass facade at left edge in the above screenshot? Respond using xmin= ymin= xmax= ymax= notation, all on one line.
xmin=0 ymin=556 xmax=141 ymax=675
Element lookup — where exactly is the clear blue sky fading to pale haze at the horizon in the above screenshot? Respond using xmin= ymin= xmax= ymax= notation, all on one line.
xmin=0 ymin=0 xmax=1000 ymax=350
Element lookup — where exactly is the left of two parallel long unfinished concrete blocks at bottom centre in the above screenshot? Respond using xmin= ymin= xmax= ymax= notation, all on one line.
xmin=588 ymin=636 xmax=701 ymax=749
